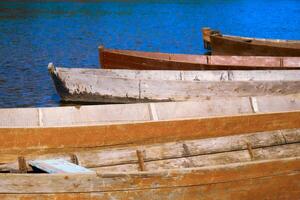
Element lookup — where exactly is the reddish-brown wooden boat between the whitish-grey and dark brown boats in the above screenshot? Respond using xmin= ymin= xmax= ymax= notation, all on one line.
xmin=99 ymin=46 xmax=300 ymax=70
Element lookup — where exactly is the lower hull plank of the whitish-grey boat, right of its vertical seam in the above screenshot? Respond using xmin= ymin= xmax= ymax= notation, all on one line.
xmin=140 ymin=80 xmax=300 ymax=102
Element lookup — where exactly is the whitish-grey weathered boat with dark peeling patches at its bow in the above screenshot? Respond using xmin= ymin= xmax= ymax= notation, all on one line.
xmin=49 ymin=64 xmax=300 ymax=103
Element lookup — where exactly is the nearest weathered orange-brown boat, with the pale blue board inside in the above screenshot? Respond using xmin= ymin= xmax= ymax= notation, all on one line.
xmin=0 ymin=129 xmax=300 ymax=200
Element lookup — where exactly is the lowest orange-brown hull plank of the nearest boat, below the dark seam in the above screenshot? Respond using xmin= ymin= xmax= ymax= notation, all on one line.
xmin=0 ymin=173 xmax=300 ymax=200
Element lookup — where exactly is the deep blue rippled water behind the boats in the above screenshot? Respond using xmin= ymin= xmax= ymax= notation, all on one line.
xmin=0 ymin=0 xmax=300 ymax=107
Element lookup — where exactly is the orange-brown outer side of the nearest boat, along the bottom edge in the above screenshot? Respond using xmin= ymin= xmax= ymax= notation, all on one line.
xmin=0 ymin=158 xmax=300 ymax=199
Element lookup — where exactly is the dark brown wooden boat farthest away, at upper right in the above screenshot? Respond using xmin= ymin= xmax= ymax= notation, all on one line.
xmin=202 ymin=28 xmax=300 ymax=57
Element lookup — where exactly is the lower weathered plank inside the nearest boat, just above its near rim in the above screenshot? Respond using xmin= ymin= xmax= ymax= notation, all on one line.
xmin=92 ymin=143 xmax=300 ymax=173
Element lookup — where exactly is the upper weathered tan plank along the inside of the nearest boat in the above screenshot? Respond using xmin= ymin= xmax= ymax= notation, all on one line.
xmin=0 ymin=129 xmax=300 ymax=171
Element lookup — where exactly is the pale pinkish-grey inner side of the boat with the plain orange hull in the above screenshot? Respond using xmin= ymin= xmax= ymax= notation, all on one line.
xmin=0 ymin=94 xmax=300 ymax=128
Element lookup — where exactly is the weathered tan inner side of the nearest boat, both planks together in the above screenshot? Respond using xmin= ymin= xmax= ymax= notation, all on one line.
xmin=0 ymin=129 xmax=300 ymax=171
